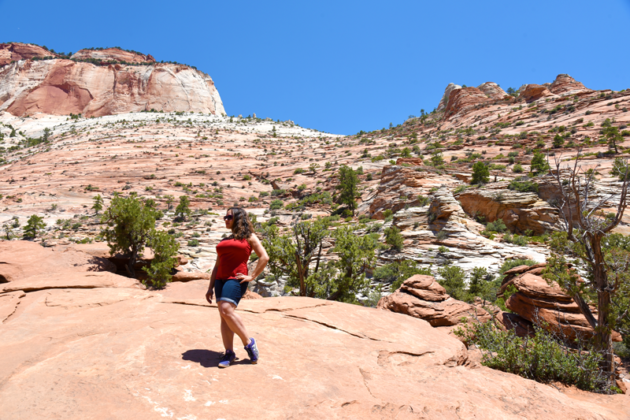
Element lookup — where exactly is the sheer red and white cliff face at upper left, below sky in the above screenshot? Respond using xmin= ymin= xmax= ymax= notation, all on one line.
xmin=0 ymin=59 xmax=225 ymax=117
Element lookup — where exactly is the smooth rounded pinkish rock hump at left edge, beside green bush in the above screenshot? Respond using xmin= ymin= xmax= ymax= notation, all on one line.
xmin=0 ymin=241 xmax=116 ymax=282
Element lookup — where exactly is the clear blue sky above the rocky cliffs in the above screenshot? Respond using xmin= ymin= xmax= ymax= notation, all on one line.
xmin=0 ymin=0 xmax=630 ymax=134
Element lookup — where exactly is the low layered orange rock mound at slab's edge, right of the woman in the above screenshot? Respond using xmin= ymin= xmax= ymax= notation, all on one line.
xmin=377 ymin=275 xmax=491 ymax=327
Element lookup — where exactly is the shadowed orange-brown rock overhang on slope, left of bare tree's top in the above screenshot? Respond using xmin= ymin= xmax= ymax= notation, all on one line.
xmin=457 ymin=188 xmax=558 ymax=233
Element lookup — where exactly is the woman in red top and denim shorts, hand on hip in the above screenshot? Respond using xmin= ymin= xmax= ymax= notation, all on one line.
xmin=206 ymin=207 xmax=269 ymax=368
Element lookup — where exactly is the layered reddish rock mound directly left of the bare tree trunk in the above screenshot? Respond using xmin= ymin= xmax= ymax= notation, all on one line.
xmin=499 ymin=264 xmax=621 ymax=341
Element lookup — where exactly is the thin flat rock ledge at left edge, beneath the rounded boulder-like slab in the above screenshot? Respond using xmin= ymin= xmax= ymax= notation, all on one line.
xmin=0 ymin=270 xmax=142 ymax=293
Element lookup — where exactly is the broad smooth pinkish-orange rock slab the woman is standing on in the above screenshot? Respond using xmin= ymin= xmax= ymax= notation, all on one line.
xmin=0 ymin=289 xmax=630 ymax=420
